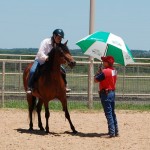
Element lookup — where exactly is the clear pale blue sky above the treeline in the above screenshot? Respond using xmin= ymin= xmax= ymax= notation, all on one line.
xmin=0 ymin=0 xmax=150 ymax=50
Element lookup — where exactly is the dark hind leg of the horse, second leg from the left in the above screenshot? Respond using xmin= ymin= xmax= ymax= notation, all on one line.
xmin=36 ymin=99 xmax=44 ymax=131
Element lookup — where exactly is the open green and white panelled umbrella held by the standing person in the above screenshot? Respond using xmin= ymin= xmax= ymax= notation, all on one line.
xmin=76 ymin=31 xmax=134 ymax=66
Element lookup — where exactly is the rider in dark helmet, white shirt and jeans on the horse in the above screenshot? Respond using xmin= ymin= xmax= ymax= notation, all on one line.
xmin=27 ymin=29 xmax=71 ymax=94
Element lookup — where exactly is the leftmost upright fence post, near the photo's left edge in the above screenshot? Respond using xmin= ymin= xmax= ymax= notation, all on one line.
xmin=2 ymin=61 xmax=5 ymax=107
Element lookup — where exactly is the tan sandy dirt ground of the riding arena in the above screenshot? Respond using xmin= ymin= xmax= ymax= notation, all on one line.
xmin=0 ymin=109 xmax=150 ymax=150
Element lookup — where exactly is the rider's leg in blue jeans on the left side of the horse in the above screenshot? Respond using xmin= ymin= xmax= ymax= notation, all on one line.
xmin=27 ymin=60 xmax=40 ymax=93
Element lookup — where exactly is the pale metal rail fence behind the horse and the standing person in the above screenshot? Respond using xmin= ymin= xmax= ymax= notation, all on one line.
xmin=0 ymin=54 xmax=150 ymax=106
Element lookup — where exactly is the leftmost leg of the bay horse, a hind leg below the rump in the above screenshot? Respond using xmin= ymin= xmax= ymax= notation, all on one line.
xmin=27 ymin=95 xmax=36 ymax=130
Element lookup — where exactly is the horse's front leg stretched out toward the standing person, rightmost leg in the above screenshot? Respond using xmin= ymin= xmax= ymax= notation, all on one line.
xmin=61 ymin=101 xmax=77 ymax=134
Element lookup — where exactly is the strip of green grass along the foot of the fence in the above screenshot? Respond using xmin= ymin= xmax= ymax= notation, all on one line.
xmin=1 ymin=101 xmax=150 ymax=111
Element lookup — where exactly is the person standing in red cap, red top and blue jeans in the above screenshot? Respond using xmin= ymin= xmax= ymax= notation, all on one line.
xmin=94 ymin=56 xmax=119 ymax=138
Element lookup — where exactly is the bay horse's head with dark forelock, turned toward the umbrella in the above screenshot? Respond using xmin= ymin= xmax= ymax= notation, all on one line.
xmin=49 ymin=42 xmax=76 ymax=68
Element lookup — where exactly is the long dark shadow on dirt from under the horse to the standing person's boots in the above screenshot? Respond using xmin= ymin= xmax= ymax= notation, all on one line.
xmin=15 ymin=128 xmax=108 ymax=138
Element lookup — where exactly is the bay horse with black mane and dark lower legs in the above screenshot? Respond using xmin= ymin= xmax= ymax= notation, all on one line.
xmin=23 ymin=43 xmax=77 ymax=134
